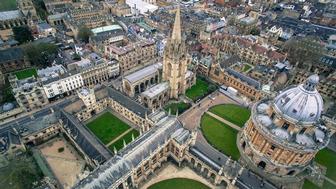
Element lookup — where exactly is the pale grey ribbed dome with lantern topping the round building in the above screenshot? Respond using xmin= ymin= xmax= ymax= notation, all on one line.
xmin=274 ymin=75 xmax=323 ymax=125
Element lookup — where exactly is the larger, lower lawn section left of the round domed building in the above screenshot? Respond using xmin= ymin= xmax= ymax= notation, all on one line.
xmin=201 ymin=114 xmax=240 ymax=160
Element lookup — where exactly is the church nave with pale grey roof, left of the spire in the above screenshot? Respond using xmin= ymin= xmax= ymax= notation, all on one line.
xmin=122 ymin=63 xmax=162 ymax=97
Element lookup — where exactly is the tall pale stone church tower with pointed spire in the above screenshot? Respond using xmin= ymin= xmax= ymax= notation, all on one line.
xmin=162 ymin=8 xmax=191 ymax=99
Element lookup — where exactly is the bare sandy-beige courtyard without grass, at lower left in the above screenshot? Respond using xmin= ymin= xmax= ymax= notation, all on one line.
xmin=39 ymin=137 xmax=86 ymax=189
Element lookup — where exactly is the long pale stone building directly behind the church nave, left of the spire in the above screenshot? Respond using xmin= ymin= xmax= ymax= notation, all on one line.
xmin=105 ymin=40 xmax=157 ymax=73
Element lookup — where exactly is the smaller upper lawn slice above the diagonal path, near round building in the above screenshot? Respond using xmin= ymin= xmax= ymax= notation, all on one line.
xmin=209 ymin=104 xmax=251 ymax=127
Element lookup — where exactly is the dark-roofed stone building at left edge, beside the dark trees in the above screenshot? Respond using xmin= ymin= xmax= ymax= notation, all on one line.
xmin=0 ymin=48 xmax=30 ymax=73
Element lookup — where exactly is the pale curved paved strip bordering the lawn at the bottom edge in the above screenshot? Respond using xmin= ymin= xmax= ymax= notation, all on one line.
xmin=140 ymin=163 xmax=223 ymax=189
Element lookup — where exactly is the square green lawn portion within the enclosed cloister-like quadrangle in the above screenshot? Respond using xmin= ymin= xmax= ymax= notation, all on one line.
xmin=86 ymin=112 xmax=130 ymax=144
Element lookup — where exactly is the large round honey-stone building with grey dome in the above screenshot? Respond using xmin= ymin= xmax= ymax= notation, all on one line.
xmin=237 ymin=75 xmax=330 ymax=182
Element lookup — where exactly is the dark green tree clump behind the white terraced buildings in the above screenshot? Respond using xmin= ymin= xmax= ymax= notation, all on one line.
xmin=24 ymin=43 xmax=58 ymax=67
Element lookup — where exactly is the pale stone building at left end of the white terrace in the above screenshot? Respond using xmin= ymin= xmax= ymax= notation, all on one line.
xmin=9 ymin=75 xmax=48 ymax=111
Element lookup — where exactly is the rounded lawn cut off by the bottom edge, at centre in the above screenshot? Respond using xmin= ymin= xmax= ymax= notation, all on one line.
xmin=148 ymin=178 xmax=210 ymax=189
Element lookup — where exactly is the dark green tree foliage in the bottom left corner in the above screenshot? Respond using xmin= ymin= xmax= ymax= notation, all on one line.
xmin=0 ymin=154 xmax=43 ymax=189
